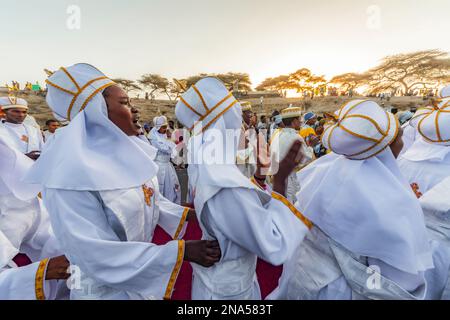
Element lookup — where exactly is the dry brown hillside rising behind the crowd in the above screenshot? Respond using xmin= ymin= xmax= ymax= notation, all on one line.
xmin=13 ymin=94 xmax=430 ymax=125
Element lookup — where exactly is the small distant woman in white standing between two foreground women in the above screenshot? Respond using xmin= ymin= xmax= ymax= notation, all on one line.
xmin=149 ymin=116 xmax=181 ymax=204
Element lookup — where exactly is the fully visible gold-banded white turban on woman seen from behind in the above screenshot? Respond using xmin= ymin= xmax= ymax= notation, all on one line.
xmin=322 ymin=100 xmax=399 ymax=160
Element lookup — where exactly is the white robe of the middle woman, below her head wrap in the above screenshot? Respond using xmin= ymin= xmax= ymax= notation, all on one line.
xmin=192 ymin=188 xmax=308 ymax=300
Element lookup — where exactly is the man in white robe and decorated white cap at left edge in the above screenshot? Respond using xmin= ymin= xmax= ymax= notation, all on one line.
xmin=0 ymin=97 xmax=44 ymax=160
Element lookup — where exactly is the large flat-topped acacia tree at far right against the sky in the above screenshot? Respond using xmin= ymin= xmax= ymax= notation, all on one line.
xmin=368 ymin=50 xmax=450 ymax=94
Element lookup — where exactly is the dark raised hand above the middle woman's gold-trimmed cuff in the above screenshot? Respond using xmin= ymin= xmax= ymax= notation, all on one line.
xmin=273 ymin=140 xmax=304 ymax=195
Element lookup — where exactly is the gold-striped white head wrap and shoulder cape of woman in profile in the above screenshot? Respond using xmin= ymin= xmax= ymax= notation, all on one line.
xmin=27 ymin=64 xmax=158 ymax=191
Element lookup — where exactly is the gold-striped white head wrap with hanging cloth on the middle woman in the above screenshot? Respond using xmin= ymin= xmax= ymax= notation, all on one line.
xmin=175 ymin=78 xmax=268 ymax=213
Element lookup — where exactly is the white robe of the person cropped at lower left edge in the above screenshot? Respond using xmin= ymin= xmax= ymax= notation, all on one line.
xmin=0 ymin=194 xmax=68 ymax=300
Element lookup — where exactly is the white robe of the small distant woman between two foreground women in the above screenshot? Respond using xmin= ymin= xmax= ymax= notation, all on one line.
xmin=150 ymin=132 xmax=181 ymax=204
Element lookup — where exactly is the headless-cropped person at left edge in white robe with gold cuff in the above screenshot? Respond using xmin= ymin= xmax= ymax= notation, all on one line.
xmin=0 ymin=139 xmax=69 ymax=300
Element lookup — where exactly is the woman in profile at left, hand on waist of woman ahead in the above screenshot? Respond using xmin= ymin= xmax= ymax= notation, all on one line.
xmin=27 ymin=64 xmax=220 ymax=299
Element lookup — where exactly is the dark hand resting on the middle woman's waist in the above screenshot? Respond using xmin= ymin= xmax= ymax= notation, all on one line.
xmin=184 ymin=240 xmax=222 ymax=267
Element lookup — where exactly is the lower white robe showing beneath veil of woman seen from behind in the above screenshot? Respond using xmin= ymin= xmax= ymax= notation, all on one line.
xmin=267 ymin=227 xmax=427 ymax=300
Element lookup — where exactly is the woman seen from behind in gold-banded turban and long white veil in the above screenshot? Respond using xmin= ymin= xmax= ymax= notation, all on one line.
xmin=271 ymin=100 xmax=433 ymax=300
